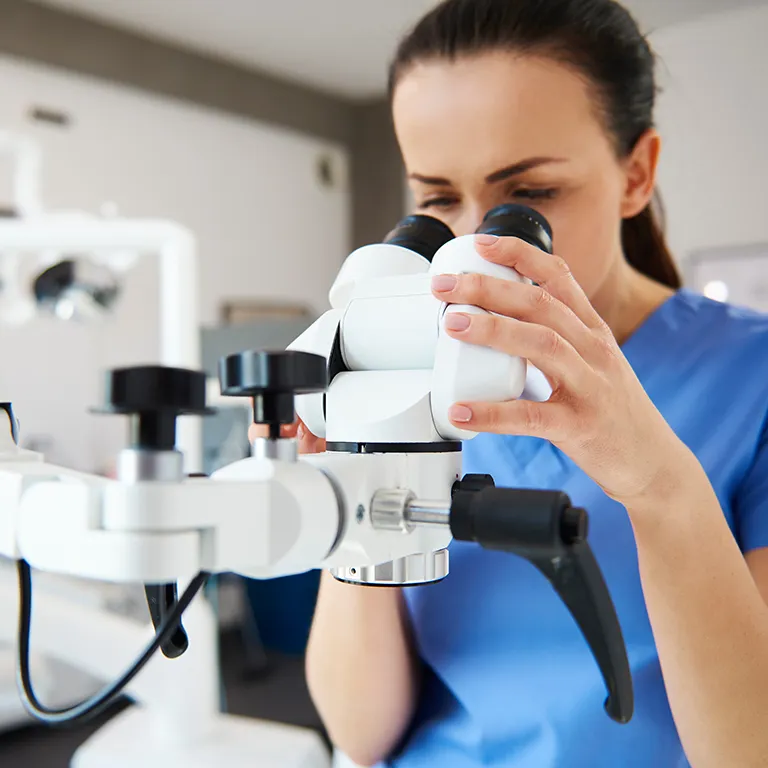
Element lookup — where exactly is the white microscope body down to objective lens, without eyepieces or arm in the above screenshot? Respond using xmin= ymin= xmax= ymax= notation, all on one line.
xmin=289 ymin=214 xmax=526 ymax=584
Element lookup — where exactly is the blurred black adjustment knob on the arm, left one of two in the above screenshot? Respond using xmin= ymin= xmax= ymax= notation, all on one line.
xmin=96 ymin=365 xmax=213 ymax=451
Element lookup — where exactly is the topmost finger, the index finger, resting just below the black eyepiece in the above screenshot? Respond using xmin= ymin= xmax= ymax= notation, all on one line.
xmin=475 ymin=235 xmax=605 ymax=329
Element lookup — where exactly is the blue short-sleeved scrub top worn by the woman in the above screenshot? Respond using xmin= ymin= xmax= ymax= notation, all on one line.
xmin=389 ymin=290 xmax=768 ymax=768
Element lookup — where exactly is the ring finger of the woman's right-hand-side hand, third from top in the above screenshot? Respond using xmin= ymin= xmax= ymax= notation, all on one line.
xmin=444 ymin=312 xmax=592 ymax=389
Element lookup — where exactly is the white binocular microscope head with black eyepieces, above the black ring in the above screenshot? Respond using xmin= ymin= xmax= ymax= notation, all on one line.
xmin=290 ymin=205 xmax=552 ymax=453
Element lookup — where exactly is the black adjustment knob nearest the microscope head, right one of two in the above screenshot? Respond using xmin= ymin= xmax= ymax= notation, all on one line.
xmin=219 ymin=351 xmax=328 ymax=438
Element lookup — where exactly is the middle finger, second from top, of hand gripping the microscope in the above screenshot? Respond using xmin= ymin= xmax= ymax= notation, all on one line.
xmin=433 ymin=274 xmax=594 ymax=354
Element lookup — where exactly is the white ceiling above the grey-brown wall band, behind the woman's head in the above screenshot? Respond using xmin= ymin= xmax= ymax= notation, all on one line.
xmin=38 ymin=0 xmax=766 ymax=98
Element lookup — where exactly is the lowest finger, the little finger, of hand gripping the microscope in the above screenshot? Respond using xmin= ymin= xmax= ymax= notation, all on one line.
xmin=449 ymin=400 xmax=573 ymax=443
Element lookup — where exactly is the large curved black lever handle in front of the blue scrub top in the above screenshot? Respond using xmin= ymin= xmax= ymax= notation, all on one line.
xmin=451 ymin=487 xmax=634 ymax=723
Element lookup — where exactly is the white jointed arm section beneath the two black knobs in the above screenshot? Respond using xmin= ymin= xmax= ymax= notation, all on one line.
xmin=9 ymin=458 xmax=340 ymax=584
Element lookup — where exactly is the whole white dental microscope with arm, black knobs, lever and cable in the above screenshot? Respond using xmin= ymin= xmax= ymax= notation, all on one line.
xmin=0 ymin=205 xmax=633 ymax=765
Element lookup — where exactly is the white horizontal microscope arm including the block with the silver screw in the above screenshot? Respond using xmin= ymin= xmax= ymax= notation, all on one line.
xmin=0 ymin=455 xmax=455 ymax=584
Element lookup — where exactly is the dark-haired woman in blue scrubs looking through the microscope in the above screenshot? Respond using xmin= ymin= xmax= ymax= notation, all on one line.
xmin=303 ymin=0 xmax=768 ymax=768
